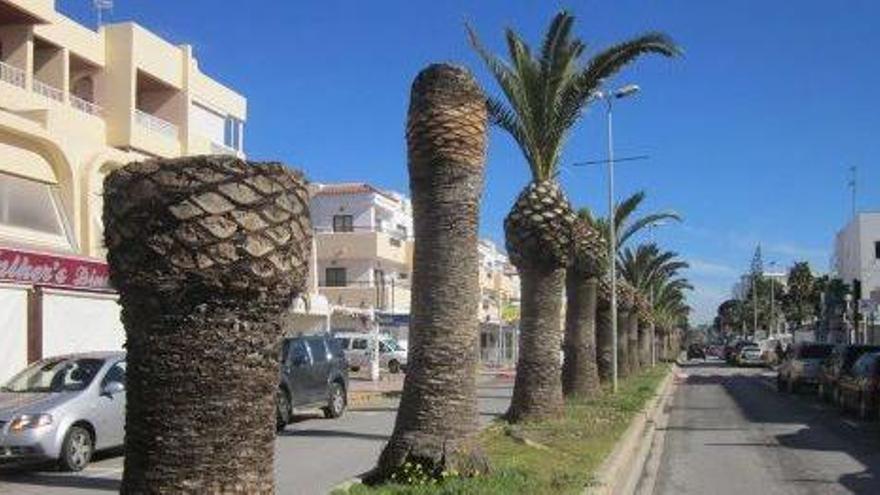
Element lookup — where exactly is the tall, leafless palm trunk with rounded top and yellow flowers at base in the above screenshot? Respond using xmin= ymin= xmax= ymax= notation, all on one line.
xmin=369 ymin=65 xmax=496 ymax=482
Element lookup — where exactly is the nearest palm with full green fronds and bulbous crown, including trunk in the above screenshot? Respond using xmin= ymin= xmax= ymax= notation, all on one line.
xmin=468 ymin=12 xmax=678 ymax=421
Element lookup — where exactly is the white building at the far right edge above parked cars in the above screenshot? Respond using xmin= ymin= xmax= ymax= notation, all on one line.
xmin=832 ymin=212 xmax=880 ymax=303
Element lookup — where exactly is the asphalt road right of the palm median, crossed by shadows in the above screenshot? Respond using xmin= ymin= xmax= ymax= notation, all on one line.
xmin=654 ymin=361 xmax=880 ymax=495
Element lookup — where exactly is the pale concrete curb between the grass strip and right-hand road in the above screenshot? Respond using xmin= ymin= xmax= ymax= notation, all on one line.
xmin=584 ymin=364 xmax=679 ymax=495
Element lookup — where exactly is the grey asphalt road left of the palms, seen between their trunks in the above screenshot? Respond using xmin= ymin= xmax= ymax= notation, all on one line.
xmin=0 ymin=380 xmax=513 ymax=495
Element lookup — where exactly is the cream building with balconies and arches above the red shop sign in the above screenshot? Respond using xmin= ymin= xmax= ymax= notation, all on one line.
xmin=0 ymin=0 xmax=247 ymax=380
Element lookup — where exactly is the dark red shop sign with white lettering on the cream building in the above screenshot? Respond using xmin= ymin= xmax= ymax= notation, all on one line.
xmin=0 ymin=247 xmax=112 ymax=291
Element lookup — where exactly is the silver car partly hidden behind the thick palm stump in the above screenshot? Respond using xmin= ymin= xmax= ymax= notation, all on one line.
xmin=0 ymin=352 xmax=125 ymax=471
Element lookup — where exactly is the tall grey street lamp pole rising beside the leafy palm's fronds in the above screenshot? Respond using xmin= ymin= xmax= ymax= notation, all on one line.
xmin=593 ymin=84 xmax=639 ymax=393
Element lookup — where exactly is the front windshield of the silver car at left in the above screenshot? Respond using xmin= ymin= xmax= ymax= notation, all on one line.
xmin=3 ymin=358 xmax=104 ymax=393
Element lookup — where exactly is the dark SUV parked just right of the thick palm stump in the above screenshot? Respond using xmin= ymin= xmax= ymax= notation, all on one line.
xmin=275 ymin=334 xmax=348 ymax=431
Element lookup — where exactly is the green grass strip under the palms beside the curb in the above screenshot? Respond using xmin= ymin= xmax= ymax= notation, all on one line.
xmin=334 ymin=364 xmax=670 ymax=495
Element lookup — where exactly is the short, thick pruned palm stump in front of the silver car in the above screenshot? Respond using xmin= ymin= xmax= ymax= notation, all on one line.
xmin=104 ymin=156 xmax=311 ymax=494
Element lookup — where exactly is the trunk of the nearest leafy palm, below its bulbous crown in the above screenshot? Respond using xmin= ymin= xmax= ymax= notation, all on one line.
xmin=506 ymin=267 xmax=565 ymax=423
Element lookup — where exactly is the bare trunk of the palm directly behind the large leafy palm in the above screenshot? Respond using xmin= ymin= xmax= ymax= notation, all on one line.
xmin=562 ymin=276 xmax=599 ymax=397
